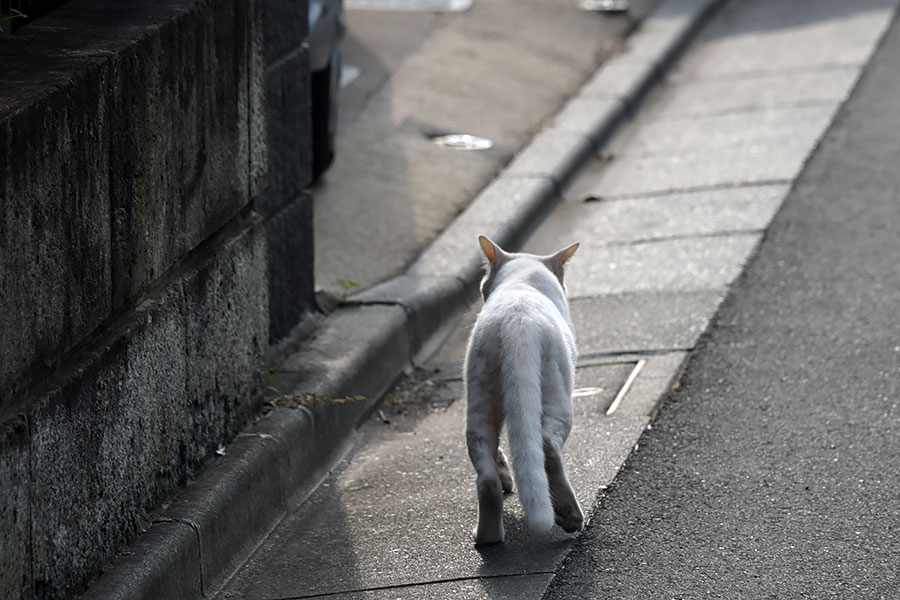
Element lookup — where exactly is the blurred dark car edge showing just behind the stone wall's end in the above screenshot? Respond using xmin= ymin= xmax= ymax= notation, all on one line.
xmin=309 ymin=0 xmax=347 ymax=180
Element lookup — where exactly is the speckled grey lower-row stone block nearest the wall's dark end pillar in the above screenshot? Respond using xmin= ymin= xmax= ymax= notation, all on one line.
xmin=180 ymin=219 xmax=269 ymax=467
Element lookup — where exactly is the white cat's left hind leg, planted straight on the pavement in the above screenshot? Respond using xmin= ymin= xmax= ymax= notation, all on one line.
xmin=466 ymin=390 xmax=509 ymax=545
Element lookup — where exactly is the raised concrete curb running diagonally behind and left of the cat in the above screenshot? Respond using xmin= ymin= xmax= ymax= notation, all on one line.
xmin=82 ymin=0 xmax=723 ymax=600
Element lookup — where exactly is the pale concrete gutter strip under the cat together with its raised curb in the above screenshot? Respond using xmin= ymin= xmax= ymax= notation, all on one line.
xmin=81 ymin=0 xmax=894 ymax=599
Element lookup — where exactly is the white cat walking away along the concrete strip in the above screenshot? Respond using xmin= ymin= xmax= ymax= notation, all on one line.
xmin=463 ymin=236 xmax=584 ymax=545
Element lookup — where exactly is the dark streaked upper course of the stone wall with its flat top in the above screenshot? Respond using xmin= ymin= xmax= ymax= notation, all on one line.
xmin=0 ymin=0 xmax=260 ymax=404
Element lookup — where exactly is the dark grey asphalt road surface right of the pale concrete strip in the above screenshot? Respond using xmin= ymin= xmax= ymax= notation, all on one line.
xmin=547 ymin=5 xmax=900 ymax=600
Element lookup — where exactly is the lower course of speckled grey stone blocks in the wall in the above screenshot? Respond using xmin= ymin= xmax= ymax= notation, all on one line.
xmin=6 ymin=221 xmax=268 ymax=596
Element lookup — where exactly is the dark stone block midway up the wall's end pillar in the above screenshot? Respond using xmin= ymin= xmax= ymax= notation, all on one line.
xmin=255 ymin=50 xmax=312 ymax=215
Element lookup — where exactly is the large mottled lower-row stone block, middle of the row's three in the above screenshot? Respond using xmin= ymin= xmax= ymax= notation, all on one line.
xmin=30 ymin=292 xmax=189 ymax=597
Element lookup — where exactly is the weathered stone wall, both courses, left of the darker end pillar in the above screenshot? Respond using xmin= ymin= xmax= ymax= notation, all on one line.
xmin=0 ymin=0 xmax=276 ymax=599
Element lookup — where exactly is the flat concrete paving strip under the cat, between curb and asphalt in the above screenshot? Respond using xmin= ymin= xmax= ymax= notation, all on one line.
xmin=218 ymin=0 xmax=895 ymax=600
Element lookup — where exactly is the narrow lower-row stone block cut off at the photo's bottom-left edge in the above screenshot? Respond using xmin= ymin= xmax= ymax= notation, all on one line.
xmin=0 ymin=418 xmax=31 ymax=598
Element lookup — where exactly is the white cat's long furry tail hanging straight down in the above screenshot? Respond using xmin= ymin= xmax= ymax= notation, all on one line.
xmin=500 ymin=319 xmax=554 ymax=532
